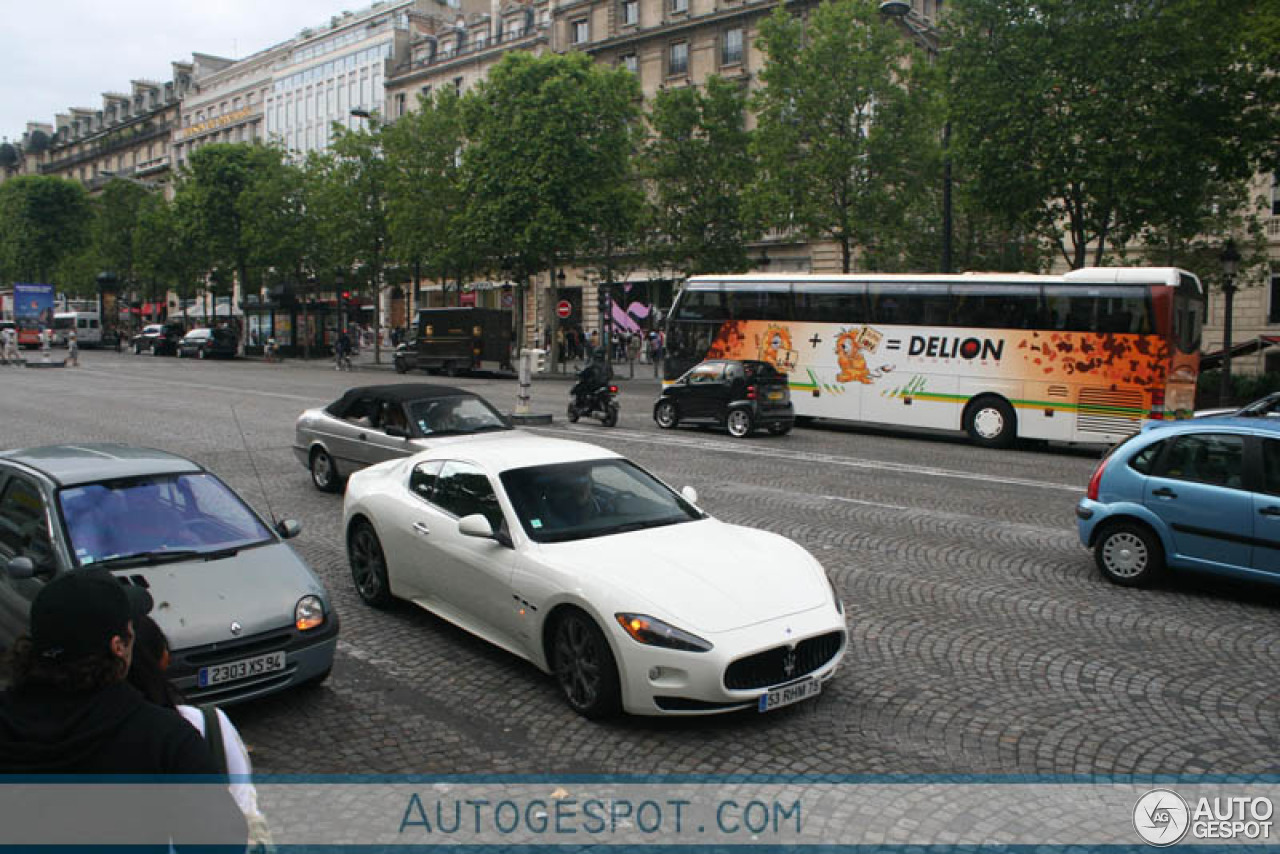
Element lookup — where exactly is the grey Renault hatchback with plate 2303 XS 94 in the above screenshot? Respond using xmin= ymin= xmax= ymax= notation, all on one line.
xmin=0 ymin=444 xmax=338 ymax=704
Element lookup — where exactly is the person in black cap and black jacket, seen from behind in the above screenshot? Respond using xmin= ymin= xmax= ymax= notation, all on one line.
xmin=0 ymin=570 xmax=247 ymax=850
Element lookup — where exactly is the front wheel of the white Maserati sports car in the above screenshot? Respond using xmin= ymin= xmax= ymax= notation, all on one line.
xmin=552 ymin=611 xmax=622 ymax=720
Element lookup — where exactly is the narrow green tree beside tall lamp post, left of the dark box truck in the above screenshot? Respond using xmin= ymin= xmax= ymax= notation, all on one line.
xmin=310 ymin=118 xmax=390 ymax=362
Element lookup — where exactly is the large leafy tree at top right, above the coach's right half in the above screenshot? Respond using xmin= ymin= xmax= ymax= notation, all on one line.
xmin=948 ymin=0 xmax=1280 ymax=268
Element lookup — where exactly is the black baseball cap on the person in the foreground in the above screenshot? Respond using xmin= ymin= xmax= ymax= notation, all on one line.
xmin=31 ymin=570 xmax=154 ymax=662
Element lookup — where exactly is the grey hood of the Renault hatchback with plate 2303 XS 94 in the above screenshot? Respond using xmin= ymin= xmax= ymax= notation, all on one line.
xmin=108 ymin=543 xmax=329 ymax=649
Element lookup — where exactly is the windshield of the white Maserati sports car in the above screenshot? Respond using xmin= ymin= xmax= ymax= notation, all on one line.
xmin=502 ymin=460 xmax=701 ymax=543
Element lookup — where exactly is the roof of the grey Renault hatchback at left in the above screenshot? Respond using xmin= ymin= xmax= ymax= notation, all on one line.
xmin=0 ymin=442 xmax=204 ymax=487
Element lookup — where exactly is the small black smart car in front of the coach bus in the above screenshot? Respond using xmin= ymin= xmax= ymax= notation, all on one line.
xmin=653 ymin=359 xmax=796 ymax=438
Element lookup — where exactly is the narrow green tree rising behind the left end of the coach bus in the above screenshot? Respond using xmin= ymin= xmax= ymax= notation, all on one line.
xmin=644 ymin=74 xmax=758 ymax=275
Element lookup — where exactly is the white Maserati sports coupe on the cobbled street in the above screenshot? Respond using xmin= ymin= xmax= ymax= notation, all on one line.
xmin=343 ymin=434 xmax=846 ymax=718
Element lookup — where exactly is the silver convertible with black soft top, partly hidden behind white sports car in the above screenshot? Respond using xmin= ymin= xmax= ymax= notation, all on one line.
xmin=293 ymin=383 xmax=513 ymax=492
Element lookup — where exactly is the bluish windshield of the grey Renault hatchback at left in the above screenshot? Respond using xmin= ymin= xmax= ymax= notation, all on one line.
xmin=58 ymin=474 xmax=273 ymax=566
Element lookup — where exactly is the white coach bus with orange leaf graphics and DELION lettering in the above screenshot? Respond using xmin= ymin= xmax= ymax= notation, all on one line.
xmin=663 ymin=268 xmax=1204 ymax=447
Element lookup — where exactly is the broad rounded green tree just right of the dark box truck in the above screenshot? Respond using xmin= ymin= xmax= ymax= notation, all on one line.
xmin=463 ymin=52 xmax=640 ymax=343
